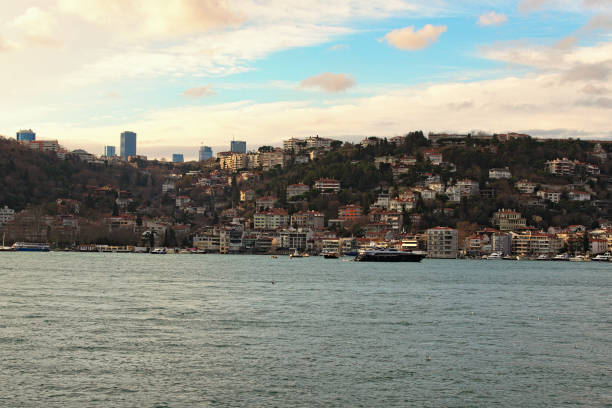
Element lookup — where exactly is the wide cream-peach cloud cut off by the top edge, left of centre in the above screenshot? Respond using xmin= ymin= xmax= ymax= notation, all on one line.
xmin=59 ymin=0 xmax=243 ymax=37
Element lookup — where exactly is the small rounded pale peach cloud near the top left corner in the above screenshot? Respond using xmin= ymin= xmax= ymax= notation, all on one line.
xmin=9 ymin=7 xmax=60 ymax=46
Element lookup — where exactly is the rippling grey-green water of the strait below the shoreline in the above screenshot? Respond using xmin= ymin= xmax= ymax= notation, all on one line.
xmin=0 ymin=253 xmax=612 ymax=407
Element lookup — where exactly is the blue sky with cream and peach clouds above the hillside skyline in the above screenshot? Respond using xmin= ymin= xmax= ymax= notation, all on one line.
xmin=0 ymin=0 xmax=612 ymax=160
